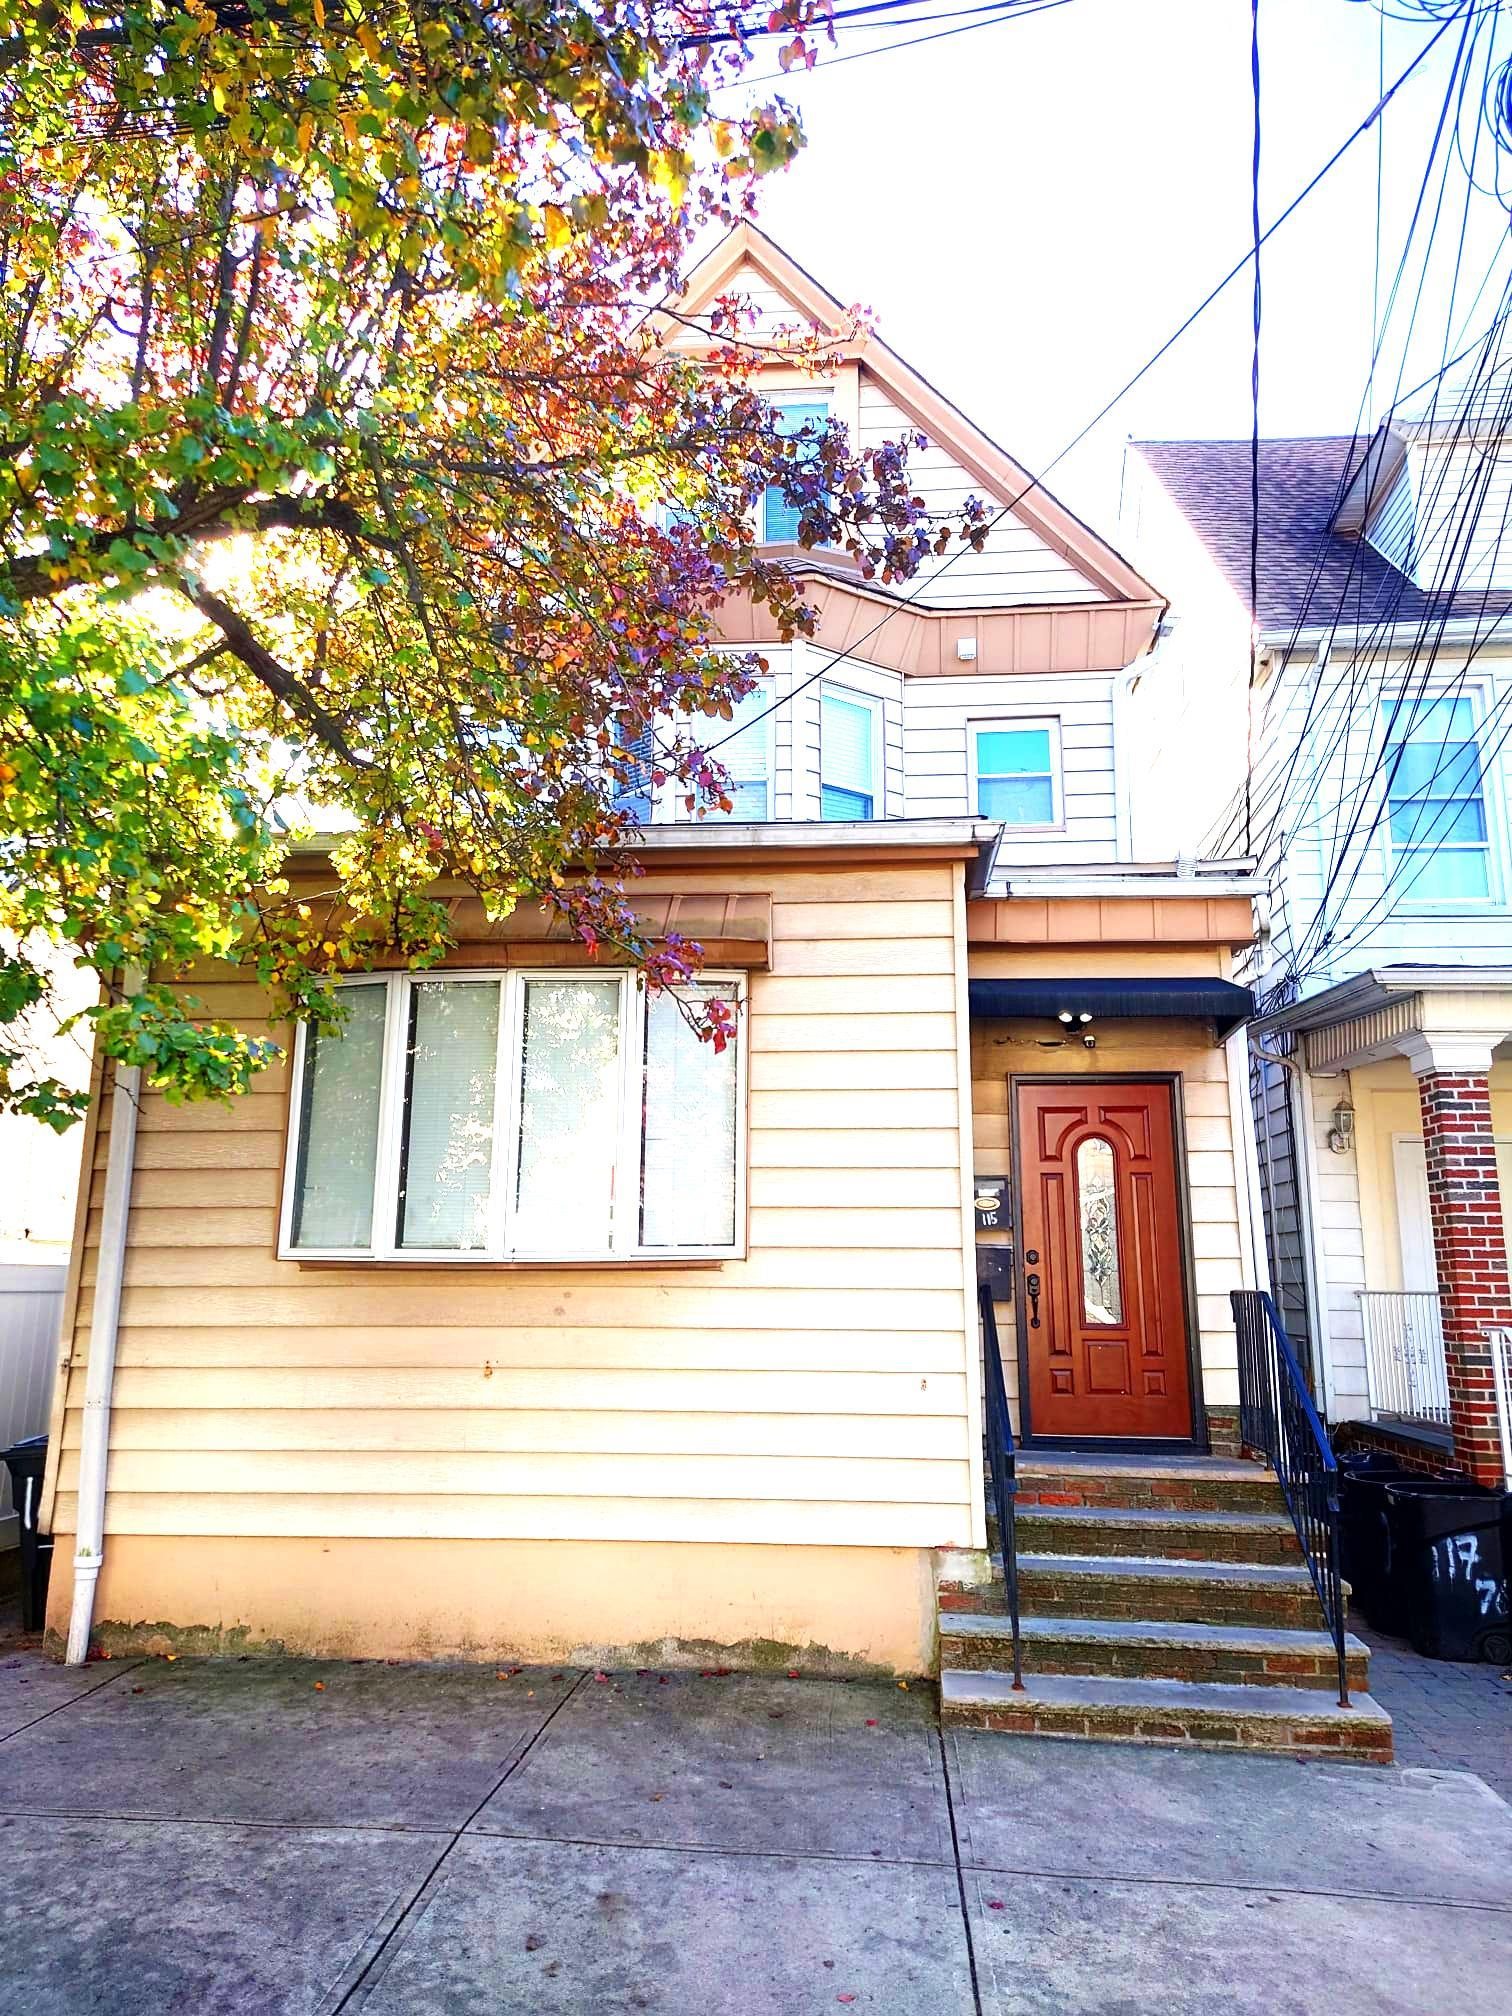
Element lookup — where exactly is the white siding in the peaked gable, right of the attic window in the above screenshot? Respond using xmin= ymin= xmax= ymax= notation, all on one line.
xmin=859 ymin=379 xmax=1107 ymax=609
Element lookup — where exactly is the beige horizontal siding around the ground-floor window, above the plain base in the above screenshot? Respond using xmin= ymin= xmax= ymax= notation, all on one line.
xmin=56 ymin=865 xmax=980 ymax=1548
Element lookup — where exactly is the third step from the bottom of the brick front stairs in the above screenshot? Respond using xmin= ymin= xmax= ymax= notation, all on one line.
xmin=1012 ymin=1550 xmax=1322 ymax=1631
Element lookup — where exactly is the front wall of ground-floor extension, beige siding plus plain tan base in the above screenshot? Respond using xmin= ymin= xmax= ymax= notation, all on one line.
xmin=41 ymin=829 xmax=982 ymax=1671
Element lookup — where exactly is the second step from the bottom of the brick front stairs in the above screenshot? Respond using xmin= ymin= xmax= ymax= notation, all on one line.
xmin=939 ymin=1611 xmax=1371 ymax=1693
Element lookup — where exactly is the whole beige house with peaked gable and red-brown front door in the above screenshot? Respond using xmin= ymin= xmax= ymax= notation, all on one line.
xmin=44 ymin=226 xmax=1282 ymax=1675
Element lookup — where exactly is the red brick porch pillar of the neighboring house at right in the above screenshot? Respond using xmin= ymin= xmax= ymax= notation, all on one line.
xmin=1417 ymin=1070 xmax=1512 ymax=1484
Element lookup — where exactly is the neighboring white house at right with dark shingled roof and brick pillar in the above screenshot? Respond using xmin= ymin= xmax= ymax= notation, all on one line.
xmin=1123 ymin=413 xmax=1512 ymax=1482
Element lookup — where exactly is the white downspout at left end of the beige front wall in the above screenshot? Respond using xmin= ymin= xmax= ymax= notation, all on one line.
xmin=65 ymin=972 xmax=141 ymax=1665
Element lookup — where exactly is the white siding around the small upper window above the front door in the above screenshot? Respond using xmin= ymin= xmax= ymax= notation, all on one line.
xmin=903 ymin=673 xmax=1119 ymax=867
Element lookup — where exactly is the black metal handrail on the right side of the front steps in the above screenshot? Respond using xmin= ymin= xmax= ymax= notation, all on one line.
xmin=1230 ymin=1288 xmax=1349 ymax=1708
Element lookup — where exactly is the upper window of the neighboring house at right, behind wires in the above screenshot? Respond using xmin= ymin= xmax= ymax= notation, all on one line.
xmin=1383 ymin=694 xmax=1492 ymax=903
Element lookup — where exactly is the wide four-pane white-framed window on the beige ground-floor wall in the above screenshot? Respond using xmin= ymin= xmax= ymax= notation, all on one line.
xmin=280 ymin=970 xmax=744 ymax=1260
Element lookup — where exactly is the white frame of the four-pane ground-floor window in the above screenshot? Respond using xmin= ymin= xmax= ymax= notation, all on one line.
xmin=278 ymin=966 xmax=750 ymax=1266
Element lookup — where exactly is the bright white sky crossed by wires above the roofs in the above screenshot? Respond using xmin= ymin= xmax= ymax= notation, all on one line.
xmin=717 ymin=0 xmax=1512 ymax=530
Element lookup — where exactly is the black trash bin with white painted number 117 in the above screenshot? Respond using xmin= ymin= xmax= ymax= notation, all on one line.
xmin=1385 ymin=1478 xmax=1512 ymax=1663
